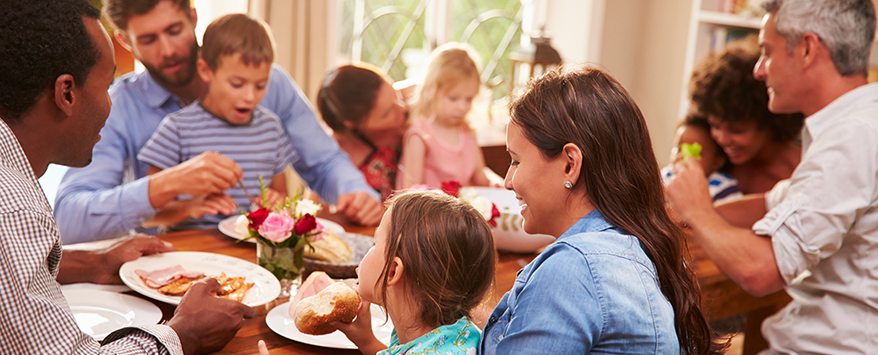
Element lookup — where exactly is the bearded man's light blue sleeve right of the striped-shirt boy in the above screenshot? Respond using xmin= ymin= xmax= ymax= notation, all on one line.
xmin=262 ymin=64 xmax=381 ymax=203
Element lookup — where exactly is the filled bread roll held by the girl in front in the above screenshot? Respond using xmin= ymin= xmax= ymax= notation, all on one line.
xmin=293 ymin=282 xmax=360 ymax=335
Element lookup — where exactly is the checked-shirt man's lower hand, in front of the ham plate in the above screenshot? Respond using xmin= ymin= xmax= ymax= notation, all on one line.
xmin=168 ymin=278 xmax=255 ymax=355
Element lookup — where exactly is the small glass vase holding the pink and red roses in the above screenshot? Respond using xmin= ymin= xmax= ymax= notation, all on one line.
xmin=256 ymin=238 xmax=305 ymax=298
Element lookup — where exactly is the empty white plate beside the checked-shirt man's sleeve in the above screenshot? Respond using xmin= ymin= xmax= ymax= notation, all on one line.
xmin=61 ymin=288 xmax=162 ymax=341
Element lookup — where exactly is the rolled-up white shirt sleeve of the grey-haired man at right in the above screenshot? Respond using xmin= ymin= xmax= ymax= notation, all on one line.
xmin=753 ymin=121 xmax=878 ymax=284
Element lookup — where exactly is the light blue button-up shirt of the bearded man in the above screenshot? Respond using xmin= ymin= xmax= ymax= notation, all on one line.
xmin=54 ymin=64 xmax=380 ymax=244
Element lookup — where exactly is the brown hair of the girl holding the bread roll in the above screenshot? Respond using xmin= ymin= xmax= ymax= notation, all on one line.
xmin=376 ymin=191 xmax=496 ymax=326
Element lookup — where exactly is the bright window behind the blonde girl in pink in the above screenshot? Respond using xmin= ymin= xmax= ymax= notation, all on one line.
xmin=338 ymin=0 xmax=532 ymax=99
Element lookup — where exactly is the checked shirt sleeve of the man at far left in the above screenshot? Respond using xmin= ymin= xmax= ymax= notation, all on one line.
xmin=0 ymin=210 xmax=182 ymax=354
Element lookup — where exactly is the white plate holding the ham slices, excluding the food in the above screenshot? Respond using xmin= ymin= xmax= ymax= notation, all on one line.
xmin=119 ymin=251 xmax=280 ymax=307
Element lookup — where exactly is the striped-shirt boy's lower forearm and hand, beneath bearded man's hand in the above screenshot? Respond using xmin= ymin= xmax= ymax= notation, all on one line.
xmin=142 ymin=194 xmax=238 ymax=228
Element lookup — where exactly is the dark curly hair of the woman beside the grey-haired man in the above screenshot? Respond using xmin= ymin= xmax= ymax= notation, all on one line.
xmin=689 ymin=35 xmax=805 ymax=143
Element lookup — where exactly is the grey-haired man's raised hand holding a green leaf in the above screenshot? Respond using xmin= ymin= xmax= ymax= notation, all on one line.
xmin=665 ymin=159 xmax=713 ymax=224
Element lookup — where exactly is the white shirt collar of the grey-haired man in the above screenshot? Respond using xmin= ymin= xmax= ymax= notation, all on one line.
xmin=802 ymin=83 xmax=878 ymax=151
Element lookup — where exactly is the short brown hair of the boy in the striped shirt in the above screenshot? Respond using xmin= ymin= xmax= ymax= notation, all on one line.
xmin=201 ymin=14 xmax=274 ymax=70
